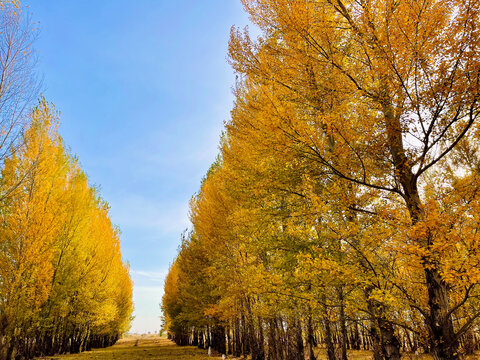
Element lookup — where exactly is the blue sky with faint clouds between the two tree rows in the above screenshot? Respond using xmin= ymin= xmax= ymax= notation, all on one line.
xmin=22 ymin=0 xmax=248 ymax=332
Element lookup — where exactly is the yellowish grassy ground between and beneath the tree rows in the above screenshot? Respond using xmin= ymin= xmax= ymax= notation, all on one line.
xmin=39 ymin=337 xmax=480 ymax=360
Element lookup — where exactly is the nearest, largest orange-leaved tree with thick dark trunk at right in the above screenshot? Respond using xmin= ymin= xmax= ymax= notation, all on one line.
xmin=230 ymin=0 xmax=479 ymax=359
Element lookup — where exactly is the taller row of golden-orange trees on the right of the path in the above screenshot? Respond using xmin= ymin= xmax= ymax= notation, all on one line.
xmin=163 ymin=0 xmax=480 ymax=360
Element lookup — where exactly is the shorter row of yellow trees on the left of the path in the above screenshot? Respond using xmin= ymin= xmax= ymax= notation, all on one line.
xmin=0 ymin=1 xmax=133 ymax=360
